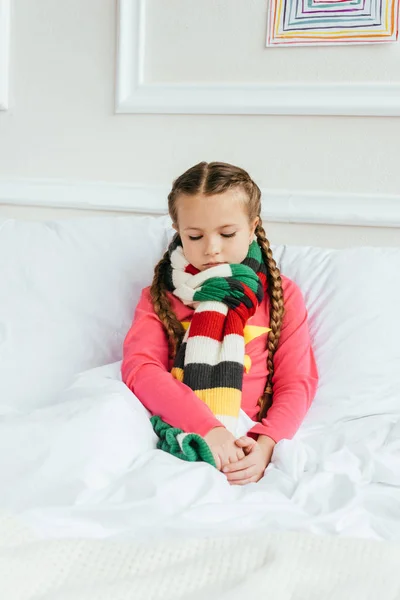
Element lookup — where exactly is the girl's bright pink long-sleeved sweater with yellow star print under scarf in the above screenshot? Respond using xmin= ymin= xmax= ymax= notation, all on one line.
xmin=122 ymin=277 xmax=318 ymax=442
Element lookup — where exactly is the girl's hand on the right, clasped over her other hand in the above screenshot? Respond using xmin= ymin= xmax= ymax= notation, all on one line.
xmin=223 ymin=435 xmax=275 ymax=485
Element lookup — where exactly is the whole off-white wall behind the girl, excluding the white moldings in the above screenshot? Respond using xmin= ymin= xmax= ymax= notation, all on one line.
xmin=0 ymin=0 xmax=400 ymax=245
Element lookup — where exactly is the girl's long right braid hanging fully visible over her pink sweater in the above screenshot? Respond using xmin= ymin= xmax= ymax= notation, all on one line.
xmin=255 ymin=218 xmax=285 ymax=421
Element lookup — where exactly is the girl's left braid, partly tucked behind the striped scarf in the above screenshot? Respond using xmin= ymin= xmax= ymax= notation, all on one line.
xmin=150 ymin=251 xmax=185 ymax=358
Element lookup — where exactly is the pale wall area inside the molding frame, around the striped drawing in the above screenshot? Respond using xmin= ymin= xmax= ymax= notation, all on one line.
xmin=145 ymin=0 xmax=400 ymax=83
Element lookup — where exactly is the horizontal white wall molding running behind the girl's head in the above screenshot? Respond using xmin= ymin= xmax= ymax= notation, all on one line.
xmin=0 ymin=177 xmax=400 ymax=227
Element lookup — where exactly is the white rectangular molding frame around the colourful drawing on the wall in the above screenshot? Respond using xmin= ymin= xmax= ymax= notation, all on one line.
xmin=115 ymin=0 xmax=400 ymax=116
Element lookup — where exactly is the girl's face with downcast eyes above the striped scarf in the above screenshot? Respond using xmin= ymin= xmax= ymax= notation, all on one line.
xmin=174 ymin=189 xmax=258 ymax=271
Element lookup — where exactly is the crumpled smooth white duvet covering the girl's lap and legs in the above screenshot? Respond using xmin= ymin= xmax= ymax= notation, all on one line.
xmin=0 ymin=363 xmax=400 ymax=541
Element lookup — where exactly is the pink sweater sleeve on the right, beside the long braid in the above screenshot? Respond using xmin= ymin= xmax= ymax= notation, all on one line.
xmin=250 ymin=279 xmax=318 ymax=442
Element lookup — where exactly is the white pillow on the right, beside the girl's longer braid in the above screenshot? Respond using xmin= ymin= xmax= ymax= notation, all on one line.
xmin=275 ymin=246 xmax=400 ymax=425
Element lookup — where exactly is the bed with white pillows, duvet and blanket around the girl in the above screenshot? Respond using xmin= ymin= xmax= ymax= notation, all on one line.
xmin=0 ymin=216 xmax=400 ymax=600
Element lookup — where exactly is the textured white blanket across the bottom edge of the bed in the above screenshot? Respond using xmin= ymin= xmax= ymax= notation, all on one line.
xmin=0 ymin=510 xmax=400 ymax=600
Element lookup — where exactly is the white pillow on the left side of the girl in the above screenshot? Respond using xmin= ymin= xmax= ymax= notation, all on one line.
xmin=0 ymin=217 xmax=170 ymax=412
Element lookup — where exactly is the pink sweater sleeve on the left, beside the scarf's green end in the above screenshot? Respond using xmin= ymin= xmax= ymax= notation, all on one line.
xmin=121 ymin=288 xmax=222 ymax=436
